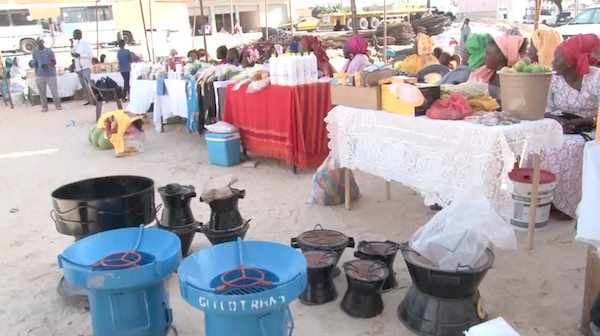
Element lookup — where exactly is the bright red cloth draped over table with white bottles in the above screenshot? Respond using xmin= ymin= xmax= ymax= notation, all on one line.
xmin=223 ymin=83 xmax=332 ymax=168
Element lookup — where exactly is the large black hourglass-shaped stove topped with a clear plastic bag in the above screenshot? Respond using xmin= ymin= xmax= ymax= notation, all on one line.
xmin=397 ymin=243 xmax=494 ymax=336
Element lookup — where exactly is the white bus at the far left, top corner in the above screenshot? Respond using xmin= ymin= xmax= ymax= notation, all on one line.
xmin=0 ymin=5 xmax=53 ymax=53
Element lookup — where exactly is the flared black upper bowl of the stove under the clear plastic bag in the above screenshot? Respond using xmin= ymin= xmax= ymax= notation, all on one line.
xmin=401 ymin=243 xmax=494 ymax=299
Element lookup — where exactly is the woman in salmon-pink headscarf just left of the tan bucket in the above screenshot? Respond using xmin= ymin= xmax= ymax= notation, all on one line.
xmin=469 ymin=35 xmax=527 ymax=99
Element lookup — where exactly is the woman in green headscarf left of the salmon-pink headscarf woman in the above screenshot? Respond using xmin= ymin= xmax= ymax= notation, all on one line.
xmin=437 ymin=33 xmax=493 ymax=85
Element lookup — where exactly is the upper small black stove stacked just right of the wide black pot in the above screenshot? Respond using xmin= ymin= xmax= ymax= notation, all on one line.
xmin=157 ymin=183 xmax=196 ymax=227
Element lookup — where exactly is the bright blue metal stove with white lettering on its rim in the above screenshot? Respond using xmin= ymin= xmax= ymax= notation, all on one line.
xmin=178 ymin=238 xmax=307 ymax=336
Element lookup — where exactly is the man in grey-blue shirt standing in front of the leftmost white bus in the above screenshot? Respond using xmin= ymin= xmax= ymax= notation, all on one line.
xmin=33 ymin=38 xmax=61 ymax=112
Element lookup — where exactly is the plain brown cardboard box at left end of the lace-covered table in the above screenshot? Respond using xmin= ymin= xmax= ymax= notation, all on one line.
xmin=331 ymin=85 xmax=381 ymax=110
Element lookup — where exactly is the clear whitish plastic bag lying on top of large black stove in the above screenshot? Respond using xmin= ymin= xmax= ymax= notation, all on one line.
xmin=410 ymin=188 xmax=517 ymax=271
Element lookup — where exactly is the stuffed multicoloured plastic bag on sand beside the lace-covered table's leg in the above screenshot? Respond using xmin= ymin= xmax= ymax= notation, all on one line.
xmin=308 ymin=156 xmax=360 ymax=205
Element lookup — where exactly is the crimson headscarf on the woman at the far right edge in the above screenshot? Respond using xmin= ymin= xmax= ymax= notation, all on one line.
xmin=558 ymin=34 xmax=600 ymax=76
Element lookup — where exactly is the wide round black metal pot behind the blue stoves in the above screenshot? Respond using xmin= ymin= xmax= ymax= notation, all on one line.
xmin=50 ymin=176 xmax=156 ymax=239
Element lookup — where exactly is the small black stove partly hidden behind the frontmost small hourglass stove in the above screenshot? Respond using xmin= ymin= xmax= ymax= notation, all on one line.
xmin=354 ymin=240 xmax=400 ymax=291
